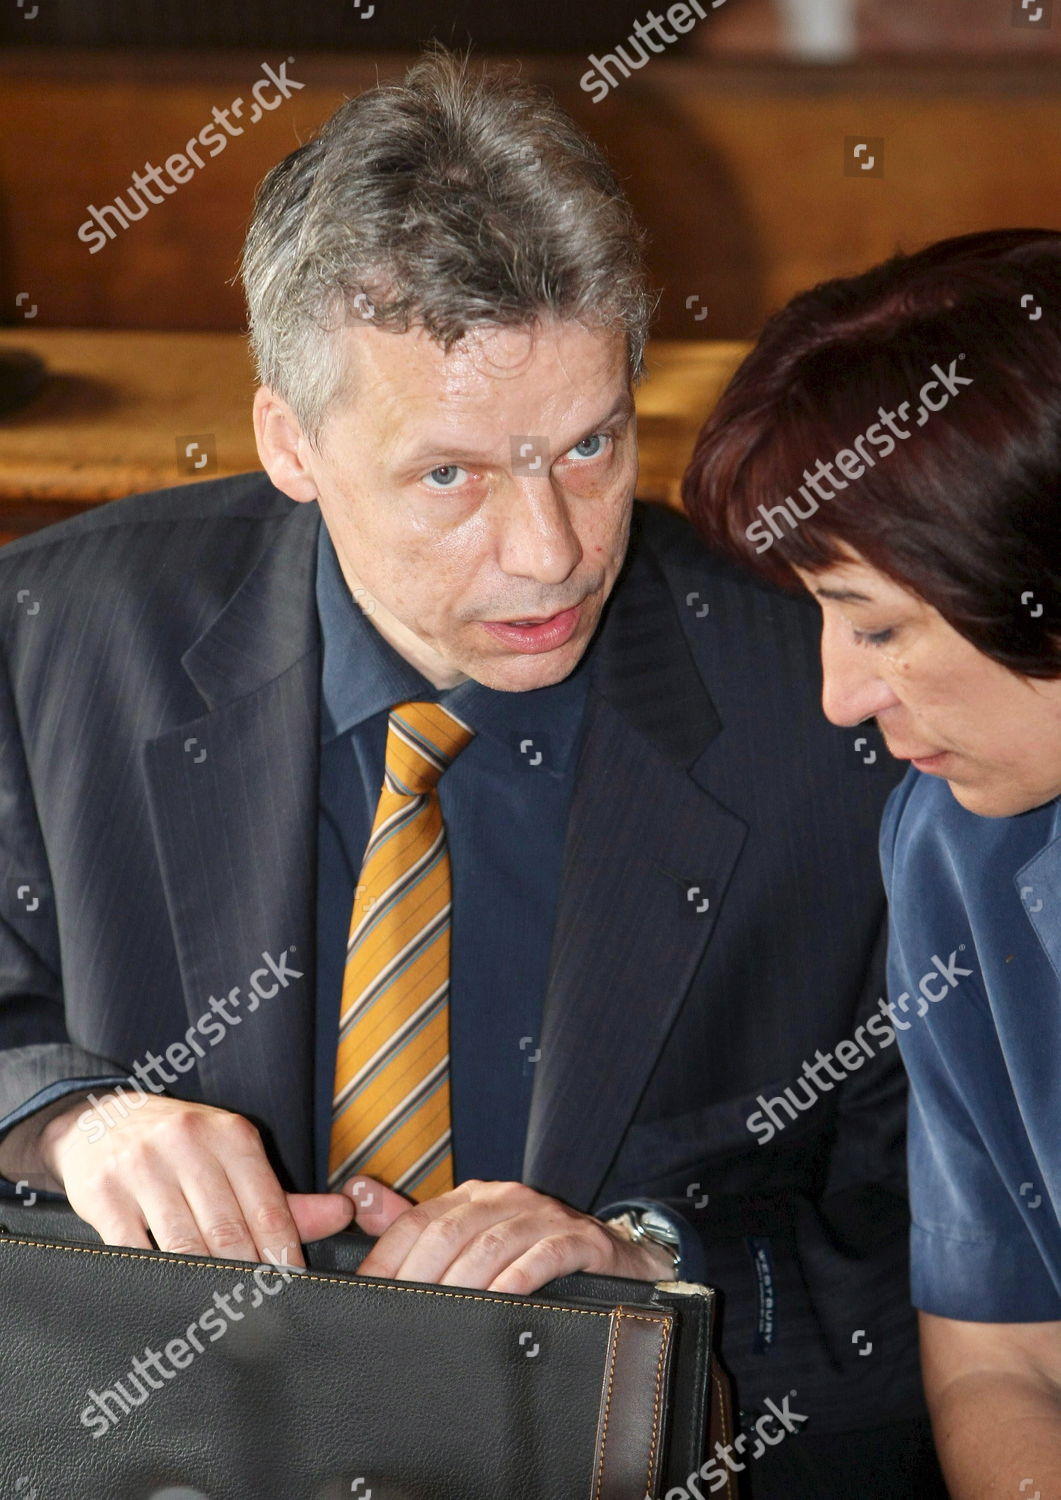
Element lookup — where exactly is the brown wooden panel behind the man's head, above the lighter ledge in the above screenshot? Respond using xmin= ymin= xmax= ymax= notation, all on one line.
xmin=0 ymin=50 xmax=1061 ymax=339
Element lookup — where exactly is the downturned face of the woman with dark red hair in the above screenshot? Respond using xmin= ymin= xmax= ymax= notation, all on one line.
xmin=797 ymin=552 xmax=1061 ymax=818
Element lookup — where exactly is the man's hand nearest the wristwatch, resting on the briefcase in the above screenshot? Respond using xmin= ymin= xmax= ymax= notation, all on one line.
xmin=344 ymin=1178 xmax=674 ymax=1296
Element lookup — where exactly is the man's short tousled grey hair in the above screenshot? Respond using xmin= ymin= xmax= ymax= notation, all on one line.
xmin=242 ymin=48 xmax=654 ymax=447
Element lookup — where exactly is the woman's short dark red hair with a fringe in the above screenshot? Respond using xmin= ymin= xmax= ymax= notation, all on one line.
xmin=683 ymin=230 xmax=1061 ymax=678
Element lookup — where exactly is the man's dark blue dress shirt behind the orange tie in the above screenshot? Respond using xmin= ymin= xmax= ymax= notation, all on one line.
xmin=315 ymin=524 xmax=591 ymax=1191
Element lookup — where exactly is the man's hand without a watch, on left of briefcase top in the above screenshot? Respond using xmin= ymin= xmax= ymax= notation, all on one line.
xmin=8 ymin=1095 xmax=351 ymax=1266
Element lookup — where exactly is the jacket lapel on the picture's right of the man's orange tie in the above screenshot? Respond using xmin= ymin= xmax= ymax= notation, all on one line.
xmin=524 ymin=525 xmax=746 ymax=1209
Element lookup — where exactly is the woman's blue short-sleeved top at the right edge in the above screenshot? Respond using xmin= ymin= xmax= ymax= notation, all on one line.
xmin=881 ymin=770 xmax=1061 ymax=1323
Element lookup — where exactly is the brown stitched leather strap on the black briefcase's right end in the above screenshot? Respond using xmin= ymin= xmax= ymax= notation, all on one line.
xmin=590 ymin=1307 xmax=674 ymax=1500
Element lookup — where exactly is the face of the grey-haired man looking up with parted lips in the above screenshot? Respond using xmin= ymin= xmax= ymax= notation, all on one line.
xmin=303 ymin=321 xmax=638 ymax=692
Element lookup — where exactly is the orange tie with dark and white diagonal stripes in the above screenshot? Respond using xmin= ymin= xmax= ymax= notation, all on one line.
xmin=329 ymin=704 xmax=474 ymax=1203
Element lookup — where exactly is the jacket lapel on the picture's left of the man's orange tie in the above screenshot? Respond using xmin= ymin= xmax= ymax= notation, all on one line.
xmin=144 ymin=504 xmax=320 ymax=1188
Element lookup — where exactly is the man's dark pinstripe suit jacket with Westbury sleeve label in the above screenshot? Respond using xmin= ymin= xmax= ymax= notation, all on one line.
xmin=0 ymin=474 xmax=920 ymax=1428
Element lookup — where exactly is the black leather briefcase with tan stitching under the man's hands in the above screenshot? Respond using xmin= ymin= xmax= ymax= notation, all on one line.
xmin=0 ymin=1202 xmax=732 ymax=1500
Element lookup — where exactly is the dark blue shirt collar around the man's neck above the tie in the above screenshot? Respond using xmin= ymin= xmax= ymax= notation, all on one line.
xmin=317 ymin=521 xmax=596 ymax=771
